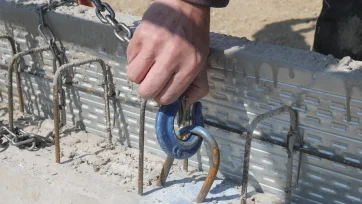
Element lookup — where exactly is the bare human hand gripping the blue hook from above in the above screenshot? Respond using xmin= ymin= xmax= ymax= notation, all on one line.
xmin=127 ymin=0 xmax=210 ymax=105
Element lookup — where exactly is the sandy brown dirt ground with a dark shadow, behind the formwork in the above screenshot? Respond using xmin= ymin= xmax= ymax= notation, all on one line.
xmin=106 ymin=0 xmax=322 ymax=50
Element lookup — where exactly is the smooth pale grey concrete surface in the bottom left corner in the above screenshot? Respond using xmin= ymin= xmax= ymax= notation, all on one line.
xmin=0 ymin=147 xmax=141 ymax=204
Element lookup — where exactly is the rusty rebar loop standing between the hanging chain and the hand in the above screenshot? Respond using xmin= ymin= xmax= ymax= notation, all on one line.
xmin=53 ymin=58 xmax=112 ymax=164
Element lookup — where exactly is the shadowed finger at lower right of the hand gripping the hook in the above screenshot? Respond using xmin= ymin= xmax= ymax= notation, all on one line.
xmin=185 ymin=68 xmax=209 ymax=107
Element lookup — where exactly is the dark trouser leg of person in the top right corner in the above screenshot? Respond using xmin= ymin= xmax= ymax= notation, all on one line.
xmin=313 ymin=0 xmax=362 ymax=61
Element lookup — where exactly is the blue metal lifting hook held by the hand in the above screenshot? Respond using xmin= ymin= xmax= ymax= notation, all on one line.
xmin=155 ymin=99 xmax=204 ymax=159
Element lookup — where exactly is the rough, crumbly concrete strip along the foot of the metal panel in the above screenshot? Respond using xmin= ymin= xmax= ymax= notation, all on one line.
xmin=0 ymin=103 xmax=281 ymax=204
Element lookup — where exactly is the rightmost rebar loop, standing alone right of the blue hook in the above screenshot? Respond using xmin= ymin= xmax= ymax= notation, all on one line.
xmin=240 ymin=106 xmax=298 ymax=204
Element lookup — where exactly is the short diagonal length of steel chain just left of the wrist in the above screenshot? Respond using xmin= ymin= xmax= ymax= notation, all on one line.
xmin=92 ymin=0 xmax=132 ymax=43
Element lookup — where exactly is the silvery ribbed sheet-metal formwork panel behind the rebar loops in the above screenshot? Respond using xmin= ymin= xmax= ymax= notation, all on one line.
xmin=0 ymin=1 xmax=362 ymax=204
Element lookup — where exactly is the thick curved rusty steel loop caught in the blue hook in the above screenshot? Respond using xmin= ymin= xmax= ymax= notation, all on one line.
xmin=156 ymin=125 xmax=220 ymax=203
